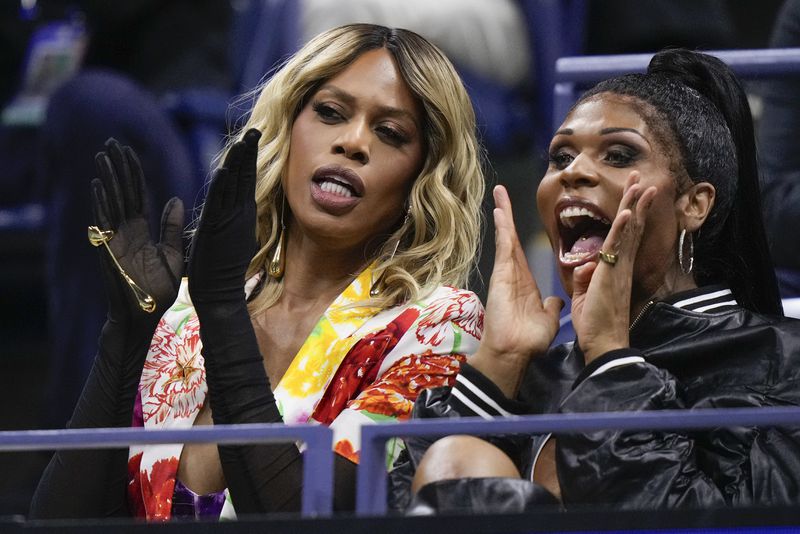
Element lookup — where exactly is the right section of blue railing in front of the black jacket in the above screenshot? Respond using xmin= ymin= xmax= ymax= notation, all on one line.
xmin=356 ymin=406 xmax=800 ymax=516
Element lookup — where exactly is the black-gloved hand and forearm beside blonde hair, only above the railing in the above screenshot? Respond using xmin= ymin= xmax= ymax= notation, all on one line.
xmin=188 ymin=130 xmax=270 ymax=424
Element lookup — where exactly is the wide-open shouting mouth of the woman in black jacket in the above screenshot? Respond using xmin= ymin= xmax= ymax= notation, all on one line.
xmin=557 ymin=204 xmax=611 ymax=267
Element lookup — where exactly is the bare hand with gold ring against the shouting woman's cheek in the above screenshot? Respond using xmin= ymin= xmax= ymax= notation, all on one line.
xmin=572 ymin=172 xmax=656 ymax=363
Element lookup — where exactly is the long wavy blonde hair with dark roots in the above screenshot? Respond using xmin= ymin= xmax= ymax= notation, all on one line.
xmin=219 ymin=24 xmax=484 ymax=314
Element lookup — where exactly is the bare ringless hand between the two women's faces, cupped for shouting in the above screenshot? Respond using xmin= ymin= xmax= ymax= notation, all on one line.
xmin=470 ymin=186 xmax=563 ymax=397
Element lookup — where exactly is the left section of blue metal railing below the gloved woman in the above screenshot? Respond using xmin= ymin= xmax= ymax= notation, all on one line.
xmin=0 ymin=424 xmax=333 ymax=517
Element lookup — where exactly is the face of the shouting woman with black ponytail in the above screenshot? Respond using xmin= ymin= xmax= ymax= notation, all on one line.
xmin=536 ymin=94 xmax=680 ymax=302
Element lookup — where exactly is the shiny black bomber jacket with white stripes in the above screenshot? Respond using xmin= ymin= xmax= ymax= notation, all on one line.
xmin=390 ymin=287 xmax=800 ymax=509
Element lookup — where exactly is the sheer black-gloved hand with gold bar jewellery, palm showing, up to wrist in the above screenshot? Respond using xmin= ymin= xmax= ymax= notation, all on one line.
xmin=90 ymin=139 xmax=183 ymax=322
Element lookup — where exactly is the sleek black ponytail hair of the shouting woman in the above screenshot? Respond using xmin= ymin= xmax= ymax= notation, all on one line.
xmin=579 ymin=49 xmax=783 ymax=315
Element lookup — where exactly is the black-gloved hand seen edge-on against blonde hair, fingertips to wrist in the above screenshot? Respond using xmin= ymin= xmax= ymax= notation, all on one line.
xmin=188 ymin=129 xmax=261 ymax=313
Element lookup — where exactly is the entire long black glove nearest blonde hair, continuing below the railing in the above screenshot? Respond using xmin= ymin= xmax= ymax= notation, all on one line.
xmin=188 ymin=130 xmax=355 ymax=515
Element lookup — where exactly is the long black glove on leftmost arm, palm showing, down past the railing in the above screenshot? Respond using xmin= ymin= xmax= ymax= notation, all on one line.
xmin=30 ymin=139 xmax=183 ymax=518
